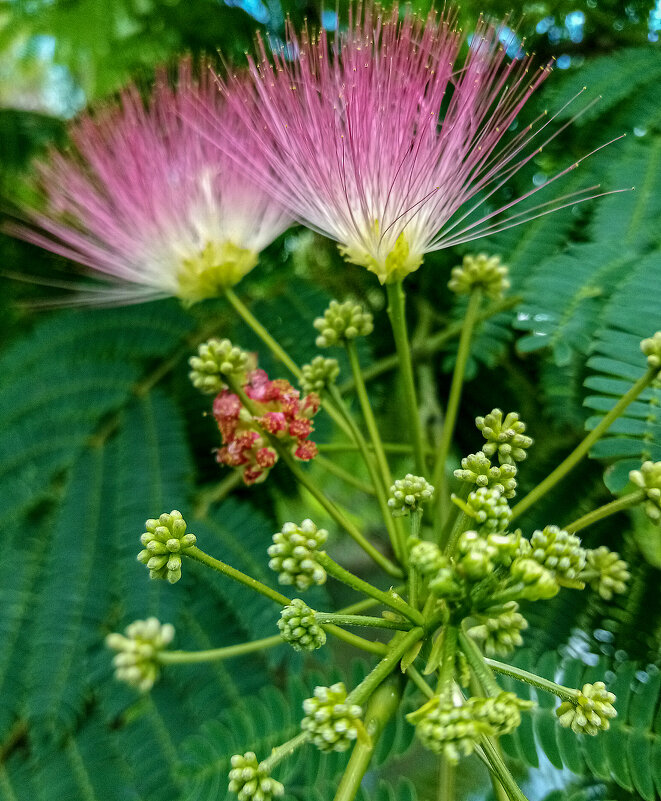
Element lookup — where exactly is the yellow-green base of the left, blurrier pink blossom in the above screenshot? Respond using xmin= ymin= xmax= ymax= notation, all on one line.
xmin=177 ymin=241 xmax=258 ymax=303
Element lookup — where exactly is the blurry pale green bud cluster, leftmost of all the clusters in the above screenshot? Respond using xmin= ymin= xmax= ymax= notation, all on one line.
xmin=106 ymin=617 xmax=174 ymax=692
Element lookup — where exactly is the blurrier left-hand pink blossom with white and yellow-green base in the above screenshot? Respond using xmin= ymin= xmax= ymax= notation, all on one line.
xmin=11 ymin=59 xmax=291 ymax=302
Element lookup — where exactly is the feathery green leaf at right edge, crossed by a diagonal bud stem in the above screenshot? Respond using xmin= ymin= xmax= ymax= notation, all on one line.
xmin=585 ymin=252 xmax=661 ymax=492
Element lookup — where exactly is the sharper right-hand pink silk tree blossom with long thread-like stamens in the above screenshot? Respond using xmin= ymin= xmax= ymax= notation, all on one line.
xmin=214 ymin=4 xmax=620 ymax=283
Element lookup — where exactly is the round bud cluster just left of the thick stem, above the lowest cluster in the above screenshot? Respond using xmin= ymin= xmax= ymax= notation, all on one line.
xmin=301 ymin=682 xmax=363 ymax=753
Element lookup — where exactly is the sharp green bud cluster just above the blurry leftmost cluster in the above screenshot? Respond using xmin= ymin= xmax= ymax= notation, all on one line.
xmin=138 ymin=509 xmax=197 ymax=584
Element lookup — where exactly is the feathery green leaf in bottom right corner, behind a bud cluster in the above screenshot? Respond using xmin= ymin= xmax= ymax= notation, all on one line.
xmin=501 ymin=651 xmax=661 ymax=801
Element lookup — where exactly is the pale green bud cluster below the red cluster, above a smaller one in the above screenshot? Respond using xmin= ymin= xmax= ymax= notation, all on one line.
xmin=267 ymin=518 xmax=328 ymax=590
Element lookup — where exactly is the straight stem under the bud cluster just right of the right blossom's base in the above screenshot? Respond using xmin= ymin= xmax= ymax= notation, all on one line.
xmin=431 ymin=289 xmax=482 ymax=536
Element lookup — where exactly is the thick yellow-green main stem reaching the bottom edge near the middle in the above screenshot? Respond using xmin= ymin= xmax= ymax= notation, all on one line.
xmin=334 ymin=678 xmax=402 ymax=801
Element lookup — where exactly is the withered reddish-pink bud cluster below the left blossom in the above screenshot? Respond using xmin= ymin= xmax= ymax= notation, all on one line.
xmin=213 ymin=370 xmax=319 ymax=484
